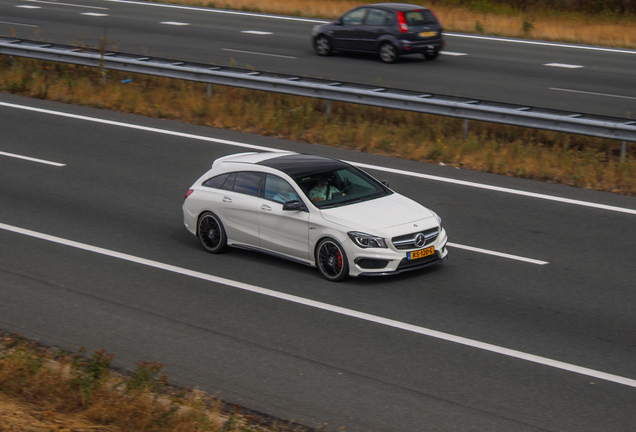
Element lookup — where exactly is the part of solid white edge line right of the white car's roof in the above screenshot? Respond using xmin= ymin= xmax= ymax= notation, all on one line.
xmin=347 ymin=161 xmax=636 ymax=215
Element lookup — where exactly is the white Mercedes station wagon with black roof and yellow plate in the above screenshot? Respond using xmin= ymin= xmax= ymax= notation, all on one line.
xmin=183 ymin=152 xmax=448 ymax=281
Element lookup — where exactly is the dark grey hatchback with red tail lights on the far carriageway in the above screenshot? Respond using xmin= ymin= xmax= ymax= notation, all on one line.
xmin=311 ymin=3 xmax=444 ymax=63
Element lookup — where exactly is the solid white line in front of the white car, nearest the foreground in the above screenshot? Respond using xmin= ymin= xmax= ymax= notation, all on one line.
xmin=0 ymin=223 xmax=636 ymax=387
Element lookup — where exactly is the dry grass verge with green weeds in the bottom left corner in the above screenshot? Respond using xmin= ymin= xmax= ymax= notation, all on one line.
xmin=0 ymin=332 xmax=310 ymax=432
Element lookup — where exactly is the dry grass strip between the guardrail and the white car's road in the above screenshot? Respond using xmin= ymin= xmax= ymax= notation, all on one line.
xmin=0 ymin=59 xmax=636 ymax=195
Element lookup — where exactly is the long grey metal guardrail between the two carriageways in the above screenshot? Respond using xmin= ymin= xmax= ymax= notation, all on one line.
xmin=0 ymin=37 xmax=636 ymax=142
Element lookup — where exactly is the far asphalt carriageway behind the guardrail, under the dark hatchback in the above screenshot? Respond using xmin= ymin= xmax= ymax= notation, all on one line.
xmin=0 ymin=0 xmax=636 ymax=117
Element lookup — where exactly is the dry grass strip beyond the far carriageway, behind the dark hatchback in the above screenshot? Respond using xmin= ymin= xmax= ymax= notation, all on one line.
xmin=150 ymin=0 xmax=636 ymax=48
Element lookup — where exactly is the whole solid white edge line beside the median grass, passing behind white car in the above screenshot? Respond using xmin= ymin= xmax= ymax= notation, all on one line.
xmin=0 ymin=102 xmax=636 ymax=215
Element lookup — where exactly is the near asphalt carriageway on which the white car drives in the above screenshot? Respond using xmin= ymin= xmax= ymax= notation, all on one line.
xmin=0 ymin=94 xmax=636 ymax=432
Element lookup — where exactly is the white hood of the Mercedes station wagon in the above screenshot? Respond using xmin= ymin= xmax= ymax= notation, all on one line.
xmin=321 ymin=194 xmax=437 ymax=234
